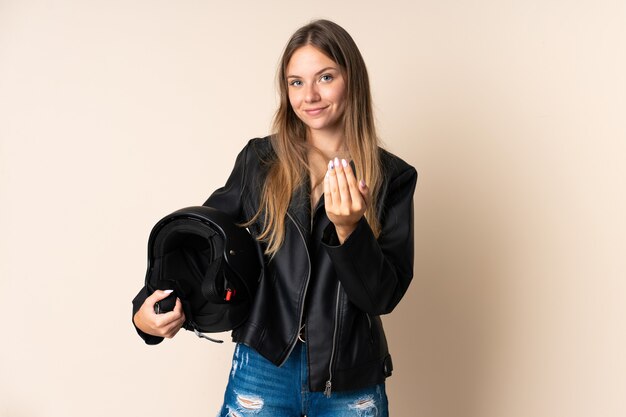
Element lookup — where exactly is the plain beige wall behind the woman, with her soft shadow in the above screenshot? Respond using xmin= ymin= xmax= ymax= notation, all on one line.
xmin=0 ymin=0 xmax=626 ymax=417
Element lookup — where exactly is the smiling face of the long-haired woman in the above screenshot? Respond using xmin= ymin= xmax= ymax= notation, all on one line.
xmin=287 ymin=45 xmax=346 ymax=134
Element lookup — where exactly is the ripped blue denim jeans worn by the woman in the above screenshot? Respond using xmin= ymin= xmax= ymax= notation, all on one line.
xmin=218 ymin=342 xmax=389 ymax=417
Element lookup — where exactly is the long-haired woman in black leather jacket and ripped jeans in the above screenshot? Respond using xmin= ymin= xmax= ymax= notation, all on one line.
xmin=134 ymin=20 xmax=417 ymax=417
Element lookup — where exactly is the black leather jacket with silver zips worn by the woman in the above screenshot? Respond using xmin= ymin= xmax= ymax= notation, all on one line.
xmin=133 ymin=138 xmax=417 ymax=391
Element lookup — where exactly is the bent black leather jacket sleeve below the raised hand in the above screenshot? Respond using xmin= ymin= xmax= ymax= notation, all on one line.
xmin=322 ymin=166 xmax=417 ymax=315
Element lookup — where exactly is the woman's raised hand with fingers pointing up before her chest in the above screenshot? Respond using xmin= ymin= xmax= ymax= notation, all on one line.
xmin=324 ymin=158 xmax=369 ymax=243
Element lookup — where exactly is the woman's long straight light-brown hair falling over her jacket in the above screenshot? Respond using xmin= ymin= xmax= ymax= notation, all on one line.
xmin=249 ymin=20 xmax=382 ymax=256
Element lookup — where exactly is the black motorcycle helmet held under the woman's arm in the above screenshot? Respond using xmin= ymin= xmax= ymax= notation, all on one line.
xmin=146 ymin=206 xmax=262 ymax=342
